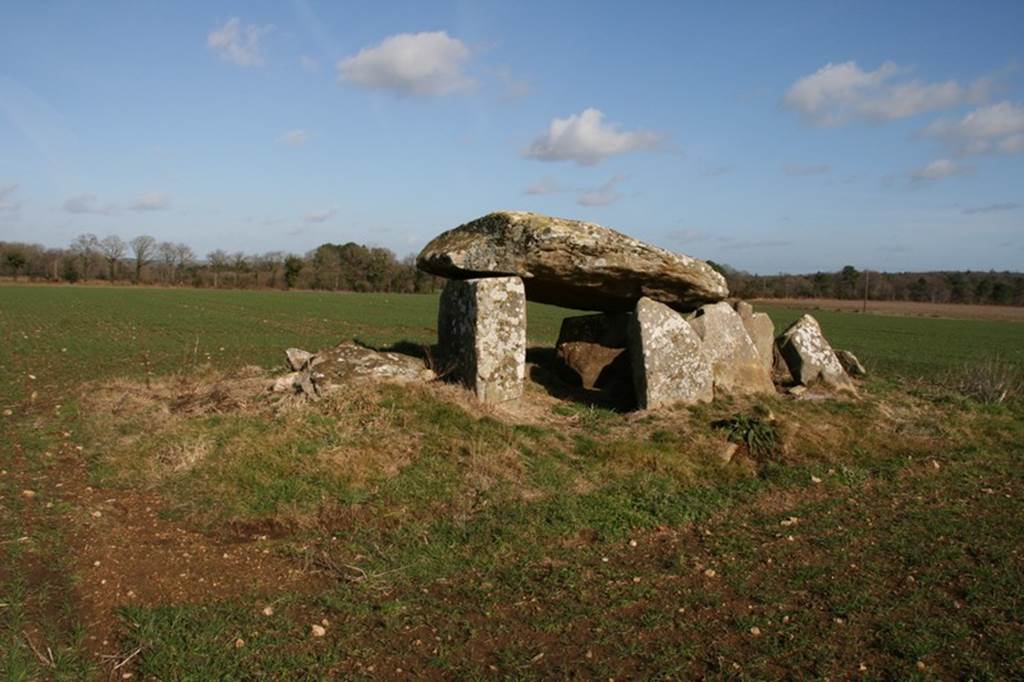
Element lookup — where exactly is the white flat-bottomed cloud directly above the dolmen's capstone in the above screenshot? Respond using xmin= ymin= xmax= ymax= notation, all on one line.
xmin=522 ymin=109 xmax=665 ymax=166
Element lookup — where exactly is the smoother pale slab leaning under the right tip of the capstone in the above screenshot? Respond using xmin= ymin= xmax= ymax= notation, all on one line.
xmin=689 ymin=302 xmax=775 ymax=393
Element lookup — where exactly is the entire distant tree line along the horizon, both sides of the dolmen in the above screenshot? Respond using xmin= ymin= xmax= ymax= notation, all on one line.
xmin=0 ymin=233 xmax=1024 ymax=305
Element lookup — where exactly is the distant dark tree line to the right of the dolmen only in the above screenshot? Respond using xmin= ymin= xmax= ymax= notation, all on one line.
xmin=712 ymin=263 xmax=1024 ymax=305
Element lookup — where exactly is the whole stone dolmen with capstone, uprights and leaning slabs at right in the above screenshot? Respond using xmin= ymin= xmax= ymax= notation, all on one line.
xmin=416 ymin=211 xmax=859 ymax=410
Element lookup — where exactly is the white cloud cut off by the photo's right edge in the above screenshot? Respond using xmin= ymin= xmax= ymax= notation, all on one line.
xmin=925 ymin=101 xmax=1024 ymax=154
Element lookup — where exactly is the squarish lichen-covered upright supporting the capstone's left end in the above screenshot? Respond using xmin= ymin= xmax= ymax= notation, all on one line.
xmin=437 ymin=276 xmax=526 ymax=402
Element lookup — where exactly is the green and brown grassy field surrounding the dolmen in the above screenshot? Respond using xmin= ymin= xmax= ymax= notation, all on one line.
xmin=0 ymin=285 xmax=1024 ymax=680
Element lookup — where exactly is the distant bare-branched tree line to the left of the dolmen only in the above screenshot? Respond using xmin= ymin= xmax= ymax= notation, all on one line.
xmin=0 ymin=233 xmax=441 ymax=293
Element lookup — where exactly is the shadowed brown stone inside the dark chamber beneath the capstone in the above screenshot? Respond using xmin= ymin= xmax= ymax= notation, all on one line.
xmin=555 ymin=313 xmax=630 ymax=390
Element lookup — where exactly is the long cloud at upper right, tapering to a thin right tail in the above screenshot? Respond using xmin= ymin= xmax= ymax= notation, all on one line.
xmin=782 ymin=61 xmax=992 ymax=126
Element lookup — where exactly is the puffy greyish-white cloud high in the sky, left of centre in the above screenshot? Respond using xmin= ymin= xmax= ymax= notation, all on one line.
xmin=337 ymin=31 xmax=475 ymax=95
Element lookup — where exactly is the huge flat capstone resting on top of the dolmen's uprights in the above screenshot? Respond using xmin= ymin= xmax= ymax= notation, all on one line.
xmin=416 ymin=211 xmax=729 ymax=312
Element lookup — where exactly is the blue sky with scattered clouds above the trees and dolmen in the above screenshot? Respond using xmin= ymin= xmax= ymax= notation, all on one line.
xmin=0 ymin=0 xmax=1024 ymax=272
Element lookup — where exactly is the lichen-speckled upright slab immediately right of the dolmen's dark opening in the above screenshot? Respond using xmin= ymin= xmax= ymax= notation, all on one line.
xmin=629 ymin=298 xmax=714 ymax=410
